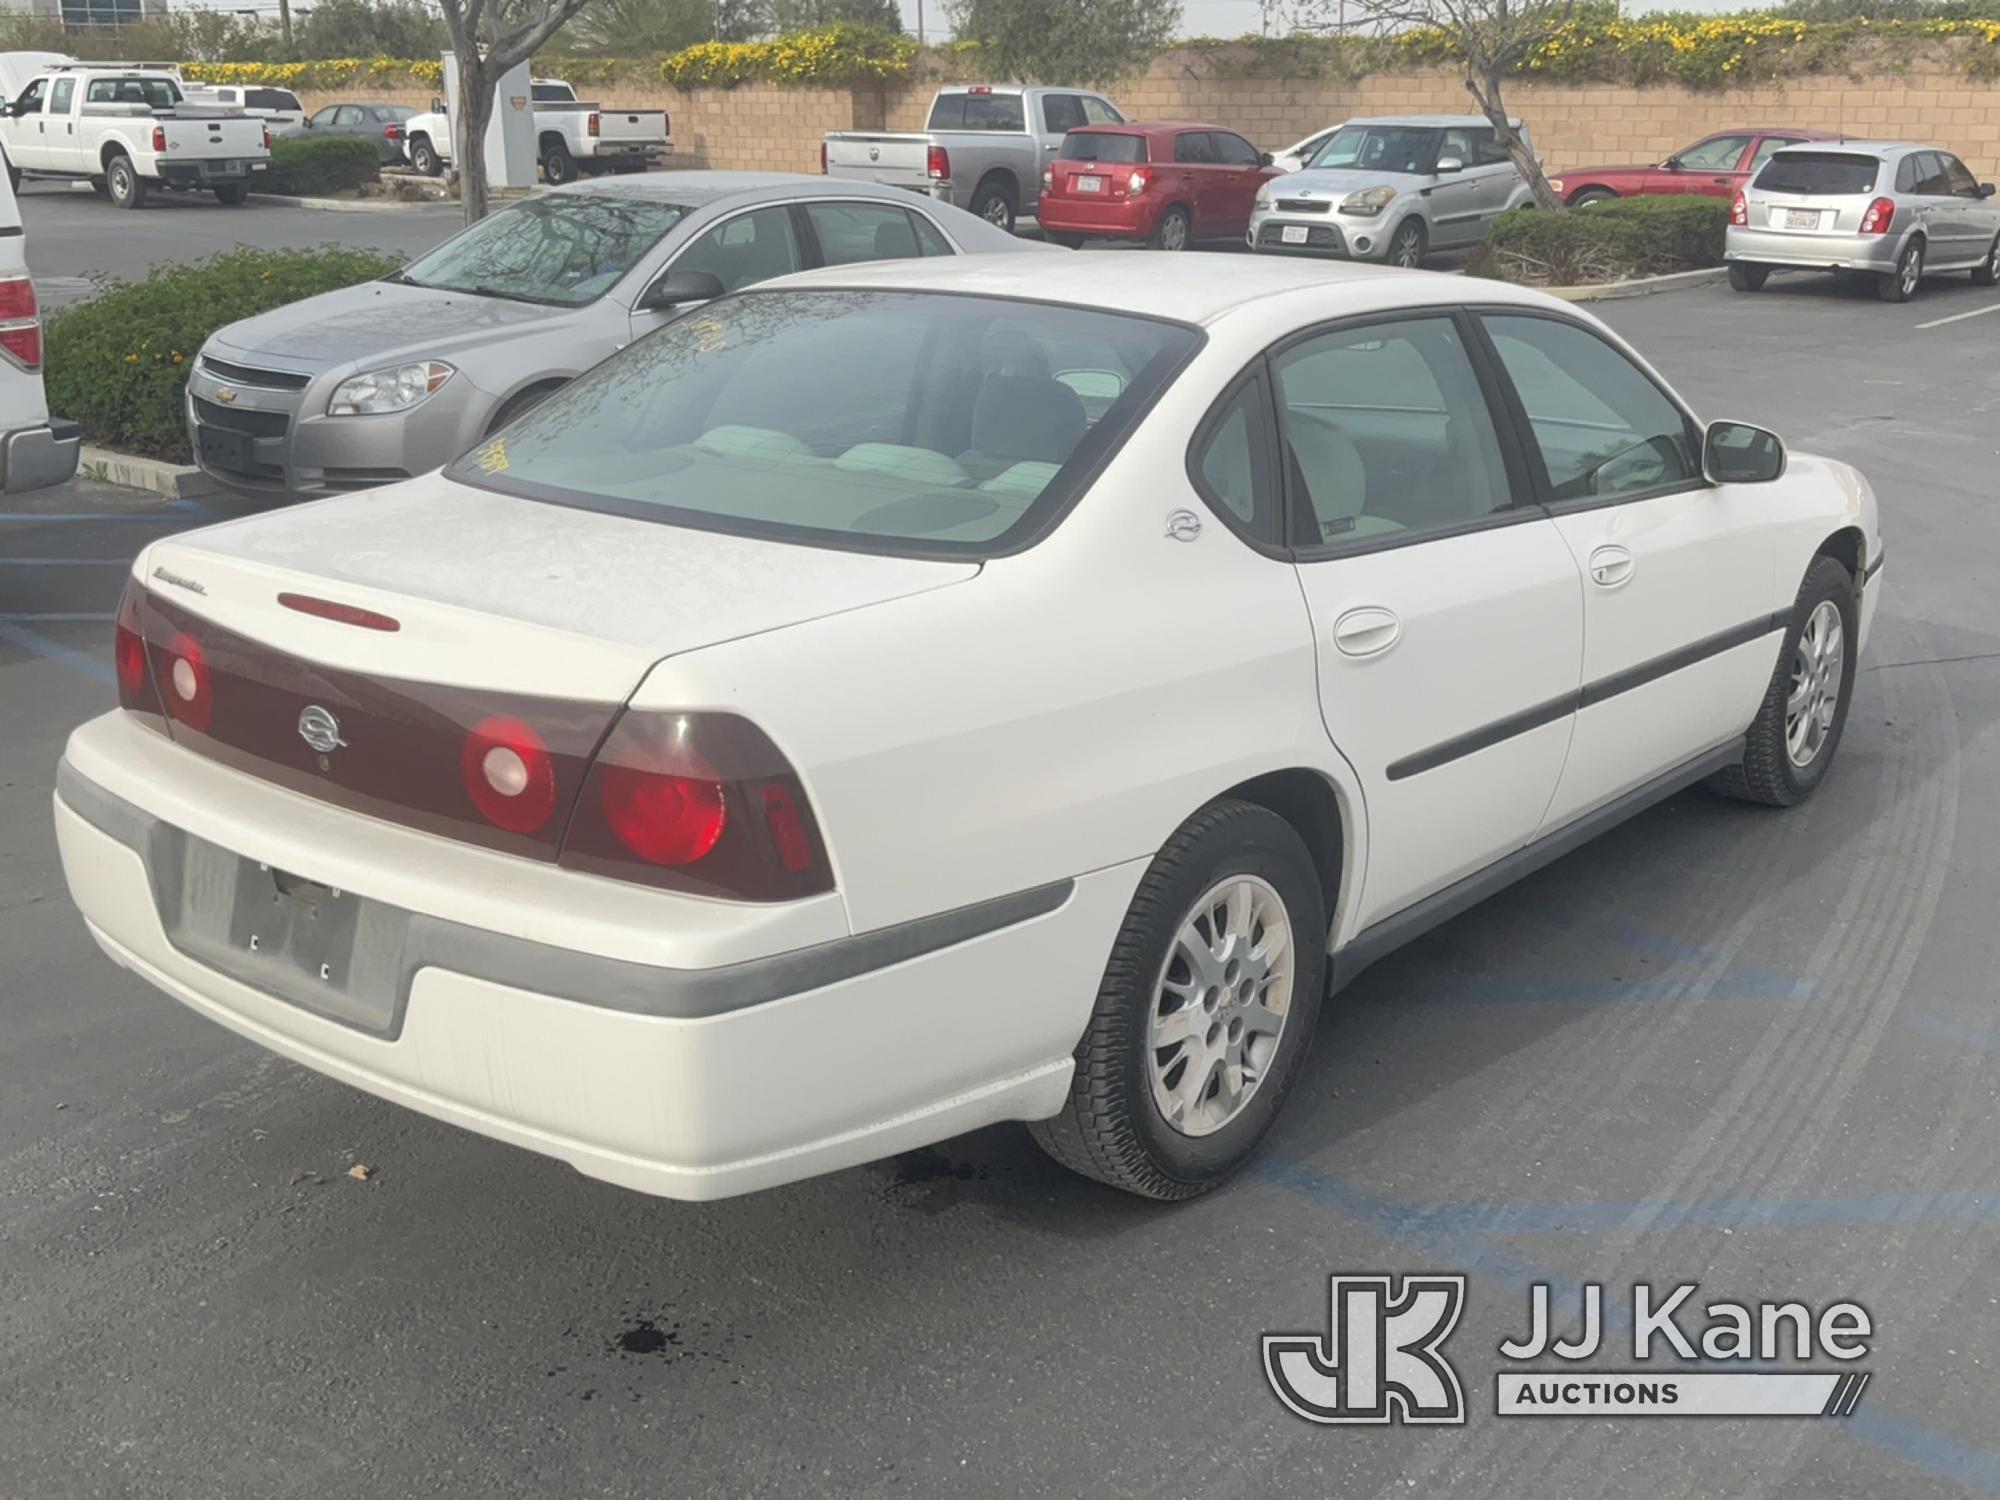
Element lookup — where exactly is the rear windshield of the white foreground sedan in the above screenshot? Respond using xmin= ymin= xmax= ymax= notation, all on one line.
xmin=450 ymin=290 xmax=1200 ymax=556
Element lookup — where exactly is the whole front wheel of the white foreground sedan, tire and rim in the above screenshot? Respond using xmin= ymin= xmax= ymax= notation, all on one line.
xmin=1710 ymin=558 xmax=1858 ymax=808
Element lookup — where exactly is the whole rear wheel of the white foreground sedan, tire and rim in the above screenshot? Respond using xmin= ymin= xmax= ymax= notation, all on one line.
xmin=1030 ymin=800 xmax=1326 ymax=1200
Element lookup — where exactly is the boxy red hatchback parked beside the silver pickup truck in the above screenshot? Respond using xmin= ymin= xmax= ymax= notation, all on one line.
xmin=1036 ymin=124 xmax=1282 ymax=250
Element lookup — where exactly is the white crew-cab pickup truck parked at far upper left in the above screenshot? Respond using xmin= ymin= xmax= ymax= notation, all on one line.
xmin=0 ymin=64 xmax=270 ymax=208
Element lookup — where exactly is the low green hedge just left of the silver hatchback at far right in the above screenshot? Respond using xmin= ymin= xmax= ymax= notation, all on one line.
xmin=1474 ymin=198 xmax=1730 ymax=286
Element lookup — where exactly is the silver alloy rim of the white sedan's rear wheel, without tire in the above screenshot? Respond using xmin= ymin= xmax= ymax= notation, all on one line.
xmin=1146 ymin=874 xmax=1294 ymax=1136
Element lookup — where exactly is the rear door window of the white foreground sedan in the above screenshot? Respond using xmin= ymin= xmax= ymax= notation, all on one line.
xmin=1272 ymin=316 xmax=1512 ymax=546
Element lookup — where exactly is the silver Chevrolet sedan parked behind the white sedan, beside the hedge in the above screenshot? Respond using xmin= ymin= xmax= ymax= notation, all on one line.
xmin=188 ymin=172 xmax=1036 ymax=498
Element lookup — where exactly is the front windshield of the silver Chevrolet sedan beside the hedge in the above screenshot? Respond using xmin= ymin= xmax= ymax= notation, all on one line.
xmin=390 ymin=192 xmax=688 ymax=308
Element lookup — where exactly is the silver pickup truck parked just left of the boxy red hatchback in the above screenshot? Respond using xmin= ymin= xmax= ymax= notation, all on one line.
xmin=820 ymin=84 xmax=1124 ymax=230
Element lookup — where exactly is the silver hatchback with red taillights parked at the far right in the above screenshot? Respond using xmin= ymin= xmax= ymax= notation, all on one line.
xmin=1722 ymin=140 xmax=2000 ymax=302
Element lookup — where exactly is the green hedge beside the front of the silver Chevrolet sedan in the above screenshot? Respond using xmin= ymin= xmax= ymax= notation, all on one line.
xmin=44 ymin=248 xmax=400 ymax=464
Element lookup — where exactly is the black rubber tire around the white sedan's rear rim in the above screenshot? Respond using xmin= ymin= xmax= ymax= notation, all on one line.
xmin=1030 ymin=800 xmax=1326 ymax=1200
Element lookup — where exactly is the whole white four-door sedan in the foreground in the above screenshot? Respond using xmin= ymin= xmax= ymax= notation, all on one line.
xmin=56 ymin=256 xmax=1882 ymax=1198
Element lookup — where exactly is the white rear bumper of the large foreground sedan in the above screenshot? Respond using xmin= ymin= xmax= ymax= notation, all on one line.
xmin=54 ymin=714 xmax=1140 ymax=1198
